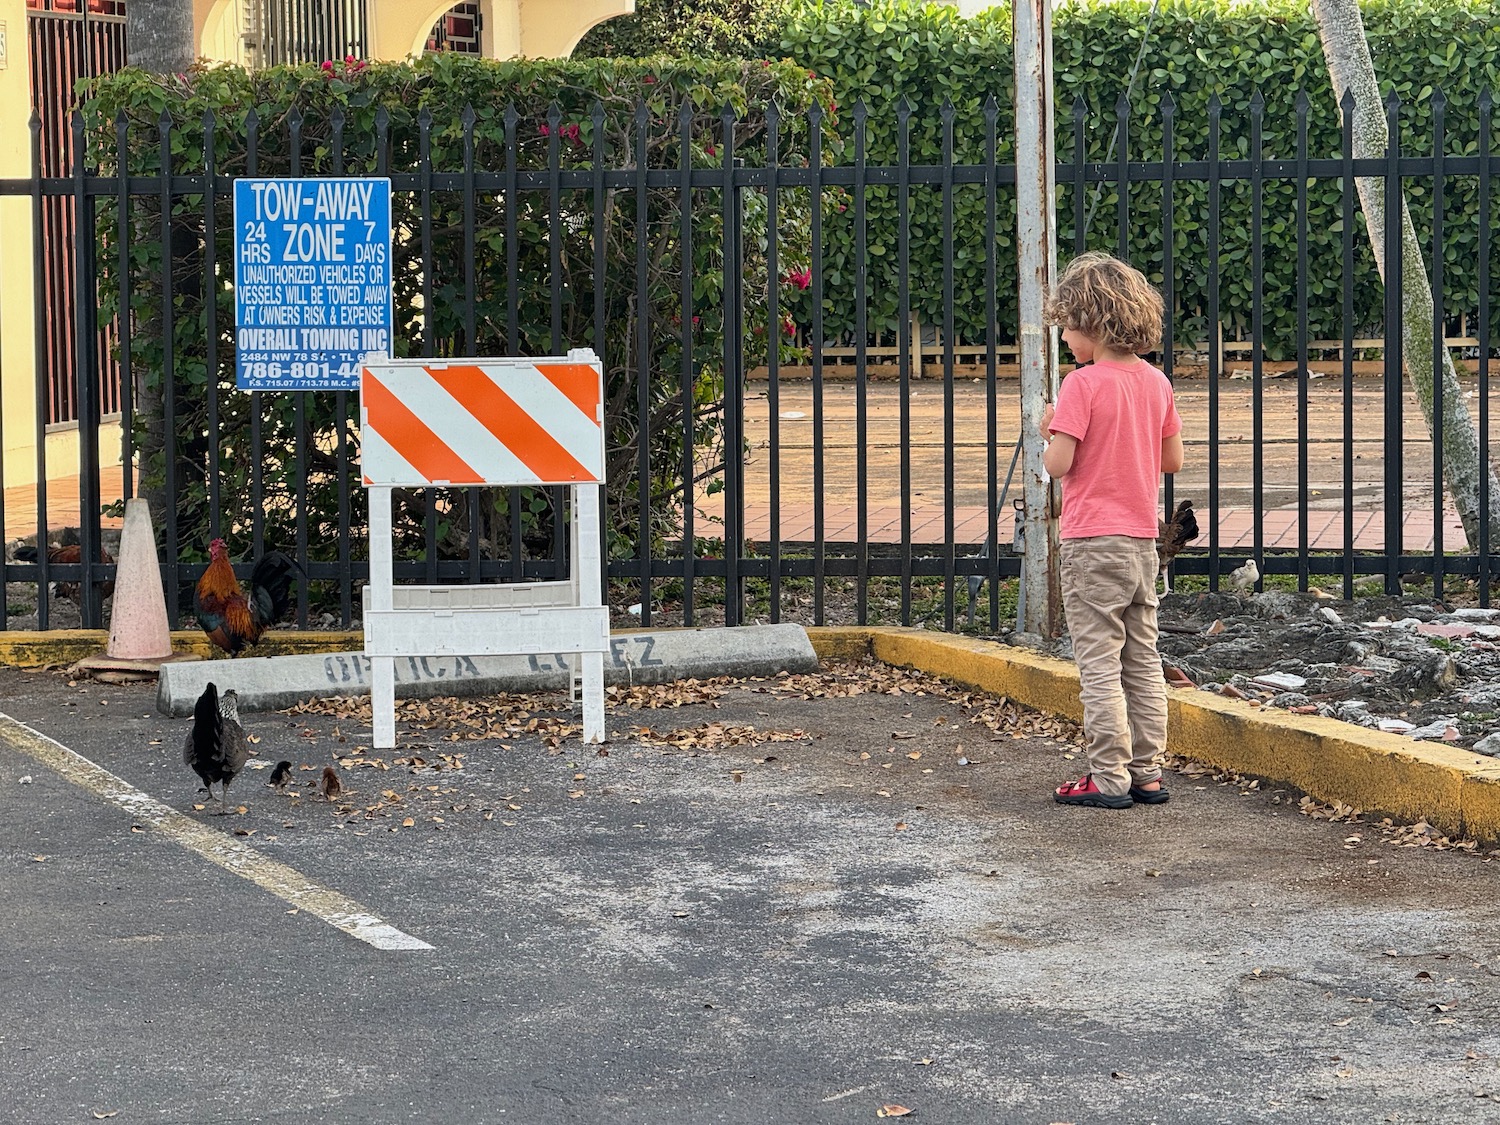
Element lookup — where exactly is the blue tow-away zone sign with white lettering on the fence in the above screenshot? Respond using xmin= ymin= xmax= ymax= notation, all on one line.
xmin=234 ymin=177 xmax=395 ymax=390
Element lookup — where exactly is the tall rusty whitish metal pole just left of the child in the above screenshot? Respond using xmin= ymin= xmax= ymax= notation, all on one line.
xmin=1011 ymin=0 xmax=1062 ymax=638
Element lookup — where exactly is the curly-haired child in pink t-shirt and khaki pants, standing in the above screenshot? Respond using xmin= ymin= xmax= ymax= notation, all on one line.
xmin=1041 ymin=254 xmax=1182 ymax=809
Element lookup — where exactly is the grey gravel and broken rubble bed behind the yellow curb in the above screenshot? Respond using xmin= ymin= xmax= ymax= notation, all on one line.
xmin=1032 ymin=591 xmax=1500 ymax=756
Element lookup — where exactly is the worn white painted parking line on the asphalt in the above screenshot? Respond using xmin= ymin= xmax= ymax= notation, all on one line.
xmin=0 ymin=711 xmax=432 ymax=950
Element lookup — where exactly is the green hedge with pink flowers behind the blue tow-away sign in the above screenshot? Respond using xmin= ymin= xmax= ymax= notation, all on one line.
xmin=86 ymin=54 xmax=828 ymax=573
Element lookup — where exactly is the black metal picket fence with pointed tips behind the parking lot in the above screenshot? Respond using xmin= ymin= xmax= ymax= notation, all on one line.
xmin=0 ymin=85 xmax=1500 ymax=629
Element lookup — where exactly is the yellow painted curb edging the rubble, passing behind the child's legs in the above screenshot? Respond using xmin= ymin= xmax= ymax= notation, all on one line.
xmin=807 ymin=627 xmax=1500 ymax=842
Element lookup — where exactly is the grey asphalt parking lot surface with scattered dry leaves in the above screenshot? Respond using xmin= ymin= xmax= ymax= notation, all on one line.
xmin=0 ymin=666 xmax=1500 ymax=1125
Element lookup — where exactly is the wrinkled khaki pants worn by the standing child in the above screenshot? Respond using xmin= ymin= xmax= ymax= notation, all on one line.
xmin=1062 ymin=536 xmax=1167 ymax=795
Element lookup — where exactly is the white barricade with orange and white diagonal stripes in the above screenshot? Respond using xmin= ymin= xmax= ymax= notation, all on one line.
xmin=360 ymin=348 xmax=609 ymax=749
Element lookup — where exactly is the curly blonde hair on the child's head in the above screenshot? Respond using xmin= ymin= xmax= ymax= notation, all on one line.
xmin=1047 ymin=251 xmax=1163 ymax=356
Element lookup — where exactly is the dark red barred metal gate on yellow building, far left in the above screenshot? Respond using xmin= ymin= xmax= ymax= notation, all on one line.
xmin=26 ymin=0 xmax=125 ymax=425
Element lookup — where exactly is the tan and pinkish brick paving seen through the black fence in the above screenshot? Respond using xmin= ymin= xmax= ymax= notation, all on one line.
xmin=5 ymin=380 xmax=1476 ymax=554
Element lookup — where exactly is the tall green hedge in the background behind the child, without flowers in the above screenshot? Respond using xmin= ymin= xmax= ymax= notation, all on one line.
xmin=782 ymin=0 xmax=1500 ymax=356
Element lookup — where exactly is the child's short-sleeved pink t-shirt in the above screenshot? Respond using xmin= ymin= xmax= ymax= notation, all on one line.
xmin=1052 ymin=360 xmax=1182 ymax=539
